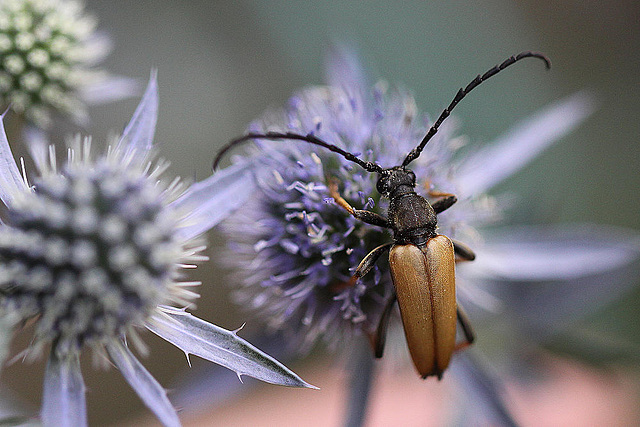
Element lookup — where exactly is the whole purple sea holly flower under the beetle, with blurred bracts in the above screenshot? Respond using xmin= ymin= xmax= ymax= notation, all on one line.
xmin=219 ymin=49 xmax=640 ymax=424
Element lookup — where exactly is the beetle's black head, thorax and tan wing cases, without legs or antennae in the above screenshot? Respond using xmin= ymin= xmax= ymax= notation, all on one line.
xmin=376 ymin=166 xmax=460 ymax=378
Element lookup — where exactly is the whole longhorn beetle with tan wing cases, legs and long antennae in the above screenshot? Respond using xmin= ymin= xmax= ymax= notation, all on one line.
xmin=213 ymin=52 xmax=551 ymax=379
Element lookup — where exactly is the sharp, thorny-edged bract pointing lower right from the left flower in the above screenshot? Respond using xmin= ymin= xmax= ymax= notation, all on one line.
xmin=147 ymin=312 xmax=315 ymax=388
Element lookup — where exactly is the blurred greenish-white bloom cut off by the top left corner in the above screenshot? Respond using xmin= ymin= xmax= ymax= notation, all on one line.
xmin=0 ymin=0 xmax=133 ymax=127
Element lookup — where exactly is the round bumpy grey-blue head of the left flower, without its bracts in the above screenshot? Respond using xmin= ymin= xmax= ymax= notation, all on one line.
xmin=0 ymin=140 xmax=196 ymax=353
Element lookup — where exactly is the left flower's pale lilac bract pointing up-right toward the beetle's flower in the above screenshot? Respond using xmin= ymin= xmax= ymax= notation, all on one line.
xmin=172 ymin=162 xmax=256 ymax=239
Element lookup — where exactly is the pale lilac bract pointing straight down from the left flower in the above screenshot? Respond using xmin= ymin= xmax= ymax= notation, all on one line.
xmin=40 ymin=351 xmax=87 ymax=427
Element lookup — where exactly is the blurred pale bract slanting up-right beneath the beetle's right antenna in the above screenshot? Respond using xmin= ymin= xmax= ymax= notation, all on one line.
xmin=456 ymin=92 xmax=595 ymax=196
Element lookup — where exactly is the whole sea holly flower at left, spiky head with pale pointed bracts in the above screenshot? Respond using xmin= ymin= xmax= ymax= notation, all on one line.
xmin=0 ymin=76 xmax=311 ymax=426
